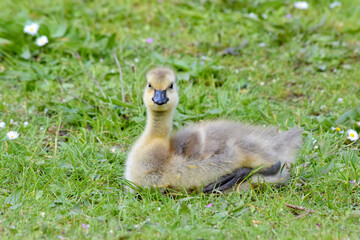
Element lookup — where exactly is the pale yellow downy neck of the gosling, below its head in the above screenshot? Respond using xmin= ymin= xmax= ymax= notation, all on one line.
xmin=144 ymin=110 xmax=174 ymax=139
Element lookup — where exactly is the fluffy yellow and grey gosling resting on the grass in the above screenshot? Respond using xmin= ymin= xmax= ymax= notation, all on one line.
xmin=125 ymin=68 xmax=301 ymax=191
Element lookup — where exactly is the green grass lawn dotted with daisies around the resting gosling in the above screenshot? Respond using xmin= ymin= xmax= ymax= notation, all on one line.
xmin=0 ymin=0 xmax=360 ymax=239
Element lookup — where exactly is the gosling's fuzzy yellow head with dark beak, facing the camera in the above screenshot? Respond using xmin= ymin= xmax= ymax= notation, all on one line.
xmin=144 ymin=68 xmax=179 ymax=112
